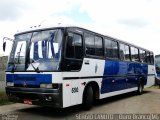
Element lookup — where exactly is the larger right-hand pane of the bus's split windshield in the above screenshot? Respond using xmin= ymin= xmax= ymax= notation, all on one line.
xmin=27 ymin=30 xmax=62 ymax=71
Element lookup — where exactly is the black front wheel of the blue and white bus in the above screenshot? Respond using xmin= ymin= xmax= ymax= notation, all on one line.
xmin=82 ymin=86 xmax=93 ymax=110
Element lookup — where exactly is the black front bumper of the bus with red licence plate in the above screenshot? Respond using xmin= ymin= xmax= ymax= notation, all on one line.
xmin=6 ymin=85 xmax=63 ymax=108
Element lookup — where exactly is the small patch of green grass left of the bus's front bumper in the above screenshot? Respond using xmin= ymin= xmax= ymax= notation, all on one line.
xmin=0 ymin=90 xmax=12 ymax=106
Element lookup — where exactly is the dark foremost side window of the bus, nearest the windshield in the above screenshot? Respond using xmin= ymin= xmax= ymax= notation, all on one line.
xmin=65 ymin=33 xmax=83 ymax=70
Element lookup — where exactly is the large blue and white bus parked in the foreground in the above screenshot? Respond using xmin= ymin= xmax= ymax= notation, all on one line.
xmin=3 ymin=25 xmax=155 ymax=109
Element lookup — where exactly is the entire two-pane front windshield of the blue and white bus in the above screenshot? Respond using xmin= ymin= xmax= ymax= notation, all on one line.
xmin=7 ymin=29 xmax=63 ymax=72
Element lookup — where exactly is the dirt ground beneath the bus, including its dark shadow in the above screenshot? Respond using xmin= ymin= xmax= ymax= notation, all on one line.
xmin=0 ymin=87 xmax=160 ymax=120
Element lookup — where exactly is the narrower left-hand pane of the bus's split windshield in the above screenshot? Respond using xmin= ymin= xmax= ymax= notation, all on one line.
xmin=7 ymin=33 xmax=31 ymax=72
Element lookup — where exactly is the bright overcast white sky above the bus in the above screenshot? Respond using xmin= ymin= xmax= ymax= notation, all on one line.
xmin=0 ymin=0 xmax=160 ymax=54
